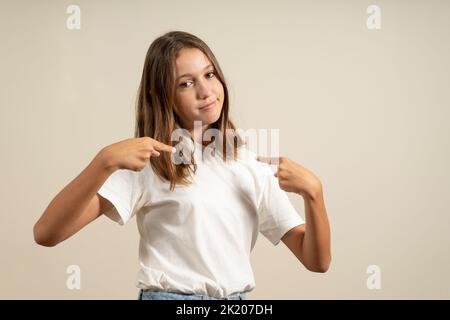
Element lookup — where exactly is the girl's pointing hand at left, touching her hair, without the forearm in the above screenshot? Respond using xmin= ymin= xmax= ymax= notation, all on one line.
xmin=99 ymin=137 xmax=176 ymax=172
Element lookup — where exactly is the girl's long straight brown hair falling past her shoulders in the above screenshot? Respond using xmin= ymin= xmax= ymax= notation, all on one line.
xmin=134 ymin=31 xmax=242 ymax=190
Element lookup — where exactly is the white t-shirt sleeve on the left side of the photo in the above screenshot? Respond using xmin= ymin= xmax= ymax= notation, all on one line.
xmin=97 ymin=164 xmax=149 ymax=225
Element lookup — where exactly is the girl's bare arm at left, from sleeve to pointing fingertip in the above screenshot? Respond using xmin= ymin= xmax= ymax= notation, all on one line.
xmin=33 ymin=137 xmax=174 ymax=247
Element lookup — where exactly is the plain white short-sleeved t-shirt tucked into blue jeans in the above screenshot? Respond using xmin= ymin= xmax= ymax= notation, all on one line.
xmin=98 ymin=142 xmax=305 ymax=298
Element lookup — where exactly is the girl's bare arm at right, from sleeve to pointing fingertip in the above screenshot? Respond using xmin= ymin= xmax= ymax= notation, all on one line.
xmin=257 ymin=157 xmax=331 ymax=272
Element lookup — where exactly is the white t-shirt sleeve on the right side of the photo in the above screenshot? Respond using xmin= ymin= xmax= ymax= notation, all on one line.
xmin=258 ymin=165 xmax=305 ymax=246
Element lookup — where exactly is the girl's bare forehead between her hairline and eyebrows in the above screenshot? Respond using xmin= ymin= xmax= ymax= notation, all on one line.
xmin=175 ymin=48 xmax=211 ymax=76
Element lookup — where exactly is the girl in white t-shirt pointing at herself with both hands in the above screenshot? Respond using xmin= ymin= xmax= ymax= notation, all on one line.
xmin=33 ymin=31 xmax=331 ymax=300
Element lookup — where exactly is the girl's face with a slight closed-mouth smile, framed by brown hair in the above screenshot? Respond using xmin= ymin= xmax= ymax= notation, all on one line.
xmin=175 ymin=48 xmax=224 ymax=133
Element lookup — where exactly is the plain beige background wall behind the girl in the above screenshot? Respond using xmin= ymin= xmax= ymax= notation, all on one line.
xmin=0 ymin=0 xmax=450 ymax=299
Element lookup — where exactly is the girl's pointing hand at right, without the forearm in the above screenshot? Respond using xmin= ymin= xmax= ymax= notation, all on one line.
xmin=256 ymin=156 xmax=322 ymax=198
